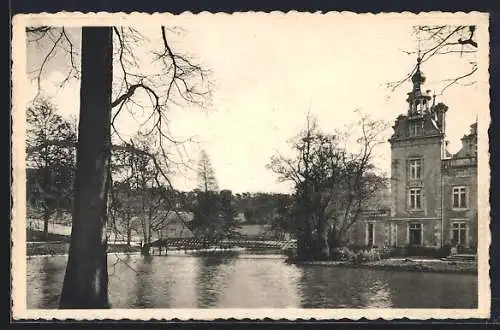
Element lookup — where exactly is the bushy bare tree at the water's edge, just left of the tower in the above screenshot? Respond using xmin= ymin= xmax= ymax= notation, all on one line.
xmin=268 ymin=116 xmax=385 ymax=259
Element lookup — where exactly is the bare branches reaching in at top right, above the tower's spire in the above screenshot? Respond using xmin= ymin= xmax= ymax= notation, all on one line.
xmin=388 ymin=25 xmax=478 ymax=94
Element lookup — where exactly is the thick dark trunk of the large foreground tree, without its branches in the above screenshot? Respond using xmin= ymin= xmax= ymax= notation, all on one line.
xmin=60 ymin=27 xmax=113 ymax=309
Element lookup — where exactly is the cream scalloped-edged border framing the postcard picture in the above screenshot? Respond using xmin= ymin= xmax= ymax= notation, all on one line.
xmin=11 ymin=11 xmax=491 ymax=320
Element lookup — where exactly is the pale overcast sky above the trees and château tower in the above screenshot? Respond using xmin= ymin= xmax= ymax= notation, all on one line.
xmin=27 ymin=15 xmax=487 ymax=192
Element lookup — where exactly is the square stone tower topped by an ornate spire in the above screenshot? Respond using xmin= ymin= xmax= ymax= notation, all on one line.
xmin=389 ymin=58 xmax=447 ymax=247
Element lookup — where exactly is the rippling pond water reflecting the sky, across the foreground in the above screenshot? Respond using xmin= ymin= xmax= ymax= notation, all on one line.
xmin=27 ymin=254 xmax=477 ymax=308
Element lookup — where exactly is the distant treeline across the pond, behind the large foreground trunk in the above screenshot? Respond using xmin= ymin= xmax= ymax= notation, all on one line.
xmin=26 ymin=99 xmax=292 ymax=248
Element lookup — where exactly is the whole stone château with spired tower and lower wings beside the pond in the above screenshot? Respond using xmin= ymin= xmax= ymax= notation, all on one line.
xmin=350 ymin=59 xmax=477 ymax=248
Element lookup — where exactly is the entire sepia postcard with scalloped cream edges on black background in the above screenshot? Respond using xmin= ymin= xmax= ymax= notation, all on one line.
xmin=11 ymin=12 xmax=491 ymax=320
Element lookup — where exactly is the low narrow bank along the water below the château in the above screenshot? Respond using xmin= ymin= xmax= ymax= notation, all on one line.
xmin=289 ymin=259 xmax=478 ymax=276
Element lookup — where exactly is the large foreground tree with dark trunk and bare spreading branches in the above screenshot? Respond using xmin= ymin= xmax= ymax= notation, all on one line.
xmin=27 ymin=23 xmax=207 ymax=308
